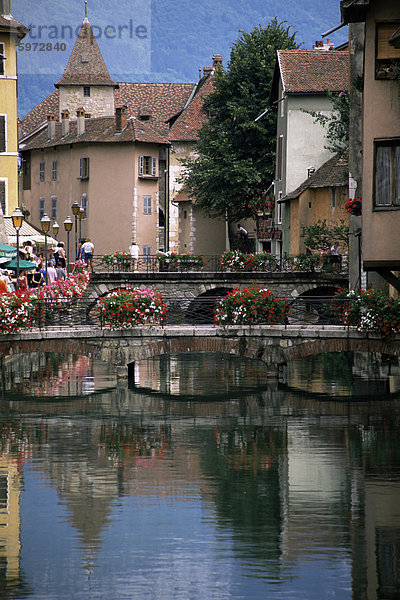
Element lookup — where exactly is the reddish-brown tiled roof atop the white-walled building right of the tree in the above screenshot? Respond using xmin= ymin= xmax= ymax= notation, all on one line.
xmin=278 ymin=50 xmax=349 ymax=94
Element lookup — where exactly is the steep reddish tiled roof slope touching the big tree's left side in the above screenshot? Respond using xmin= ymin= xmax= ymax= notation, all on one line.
xmin=168 ymin=69 xmax=213 ymax=141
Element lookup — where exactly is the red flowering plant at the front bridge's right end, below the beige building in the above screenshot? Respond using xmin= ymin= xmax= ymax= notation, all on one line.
xmin=331 ymin=288 xmax=400 ymax=338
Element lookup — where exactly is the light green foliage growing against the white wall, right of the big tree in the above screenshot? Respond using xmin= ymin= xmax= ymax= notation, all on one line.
xmin=304 ymin=90 xmax=350 ymax=153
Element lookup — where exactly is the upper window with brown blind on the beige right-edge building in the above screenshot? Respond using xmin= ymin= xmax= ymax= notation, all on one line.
xmin=375 ymin=21 xmax=400 ymax=79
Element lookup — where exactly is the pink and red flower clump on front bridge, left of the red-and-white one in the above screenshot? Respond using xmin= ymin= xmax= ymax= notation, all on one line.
xmin=96 ymin=288 xmax=167 ymax=329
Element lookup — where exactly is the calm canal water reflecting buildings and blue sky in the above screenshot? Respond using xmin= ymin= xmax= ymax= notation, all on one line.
xmin=0 ymin=353 xmax=400 ymax=600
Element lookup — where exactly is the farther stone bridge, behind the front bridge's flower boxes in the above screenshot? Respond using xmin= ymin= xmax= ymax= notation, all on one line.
xmin=82 ymin=272 xmax=348 ymax=306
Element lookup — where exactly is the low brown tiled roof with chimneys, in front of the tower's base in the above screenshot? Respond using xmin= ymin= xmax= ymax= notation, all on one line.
xmin=21 ymin=117 xmax=169 ymax=150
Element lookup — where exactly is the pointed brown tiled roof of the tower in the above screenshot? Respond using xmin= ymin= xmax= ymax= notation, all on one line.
xmin=54 ymin=17 xmax=118 ymax=87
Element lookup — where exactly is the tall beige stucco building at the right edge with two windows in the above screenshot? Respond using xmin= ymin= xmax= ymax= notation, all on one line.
xmin=341 ymin=0 xmax=400 ymax=290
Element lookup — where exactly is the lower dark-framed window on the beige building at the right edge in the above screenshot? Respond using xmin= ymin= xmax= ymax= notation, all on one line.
xmin=374 ymin=140 xmax=400 ymax=208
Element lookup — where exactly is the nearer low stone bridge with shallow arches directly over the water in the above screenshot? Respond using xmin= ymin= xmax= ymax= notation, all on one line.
xmin=0 ymin=325 xmax=400 ymax=378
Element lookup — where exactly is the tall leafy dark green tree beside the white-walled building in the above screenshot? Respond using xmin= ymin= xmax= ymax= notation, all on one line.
xmin=181 ymin=18 xmax=298 ymax=221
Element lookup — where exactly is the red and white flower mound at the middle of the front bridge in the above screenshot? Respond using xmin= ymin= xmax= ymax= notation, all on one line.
xmin=214 ymin=283 xmax=290 ymax=326
